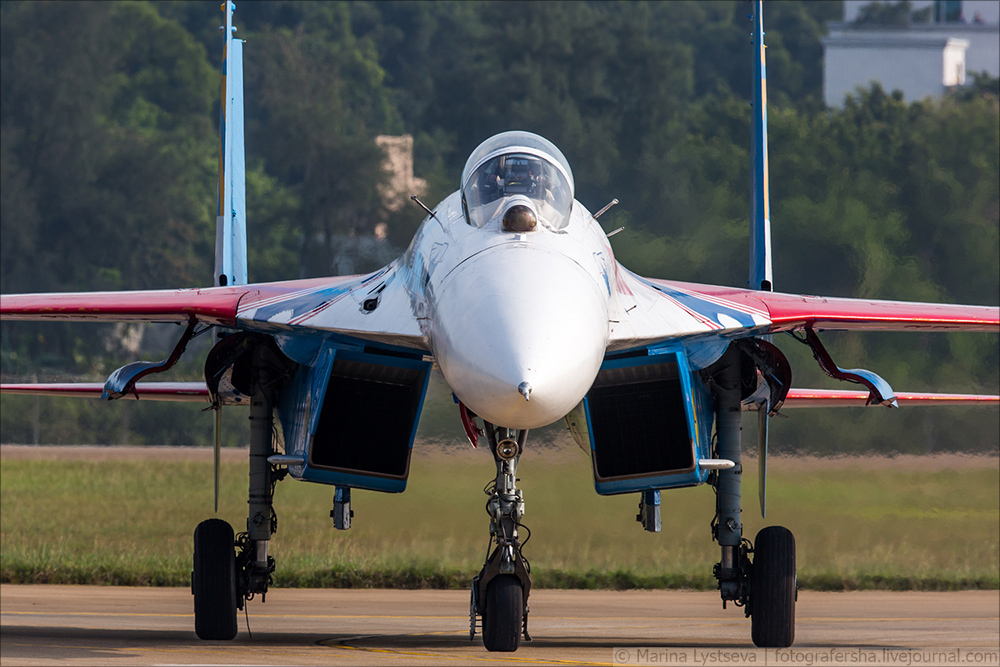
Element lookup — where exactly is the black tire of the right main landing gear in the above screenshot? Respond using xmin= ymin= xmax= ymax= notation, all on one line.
xmin=750 ymin=526 xmax=796 ymax=648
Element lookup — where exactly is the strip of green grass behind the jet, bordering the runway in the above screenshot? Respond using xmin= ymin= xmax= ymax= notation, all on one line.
xmin=0 ymin=445 xmax=1000 ymax=590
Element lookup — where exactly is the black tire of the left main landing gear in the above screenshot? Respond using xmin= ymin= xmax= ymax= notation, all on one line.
xmin=191 ymin=519 xmax=236 ymax=640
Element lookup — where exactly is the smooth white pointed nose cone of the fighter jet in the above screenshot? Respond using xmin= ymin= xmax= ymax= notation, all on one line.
xmin=433 ymin=247 xmax=608 ymax=428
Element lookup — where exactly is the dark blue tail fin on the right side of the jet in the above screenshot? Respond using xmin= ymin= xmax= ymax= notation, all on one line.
xmin=750 ymin=0 xmax=772 ymax=292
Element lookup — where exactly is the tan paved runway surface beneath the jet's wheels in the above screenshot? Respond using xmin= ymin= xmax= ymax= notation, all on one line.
xmin=0 ymin=585 xmax=1000 ymax=667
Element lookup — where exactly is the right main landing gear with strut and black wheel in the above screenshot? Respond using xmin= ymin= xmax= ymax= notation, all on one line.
xmin=712 ymin=347 xmax=798 ymax=648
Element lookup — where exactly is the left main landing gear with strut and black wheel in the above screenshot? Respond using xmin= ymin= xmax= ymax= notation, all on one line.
xmin=191 ymin=346 xmax=286 ymax=640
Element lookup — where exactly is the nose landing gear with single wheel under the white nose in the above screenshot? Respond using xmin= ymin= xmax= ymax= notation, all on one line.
xmin=469 ymin=422 xmax=531 ymax=652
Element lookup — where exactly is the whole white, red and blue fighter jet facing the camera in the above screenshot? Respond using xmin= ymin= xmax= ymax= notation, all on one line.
xmin=0 ymin=2 xmax=1000 ymax=651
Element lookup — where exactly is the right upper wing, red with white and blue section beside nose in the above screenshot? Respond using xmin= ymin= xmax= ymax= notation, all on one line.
xmin=609 ymin=266 xmax=1000 ymax=349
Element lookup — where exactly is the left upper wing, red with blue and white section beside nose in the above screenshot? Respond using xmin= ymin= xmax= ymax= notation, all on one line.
xmin=0 ymin=264 xmax=428 ymax=349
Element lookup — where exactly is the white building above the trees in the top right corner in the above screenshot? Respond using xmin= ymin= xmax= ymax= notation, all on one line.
xmin=823 ymin=0 xmax=1000 ymax=106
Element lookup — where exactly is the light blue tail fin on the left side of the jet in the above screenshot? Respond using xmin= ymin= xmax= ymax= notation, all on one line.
xmin=215 ymin=0 xmax=247 ymax=285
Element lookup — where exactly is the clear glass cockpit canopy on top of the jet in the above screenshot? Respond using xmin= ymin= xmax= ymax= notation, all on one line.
xmin=462 ymin=131 xmax=574 ymax=231
